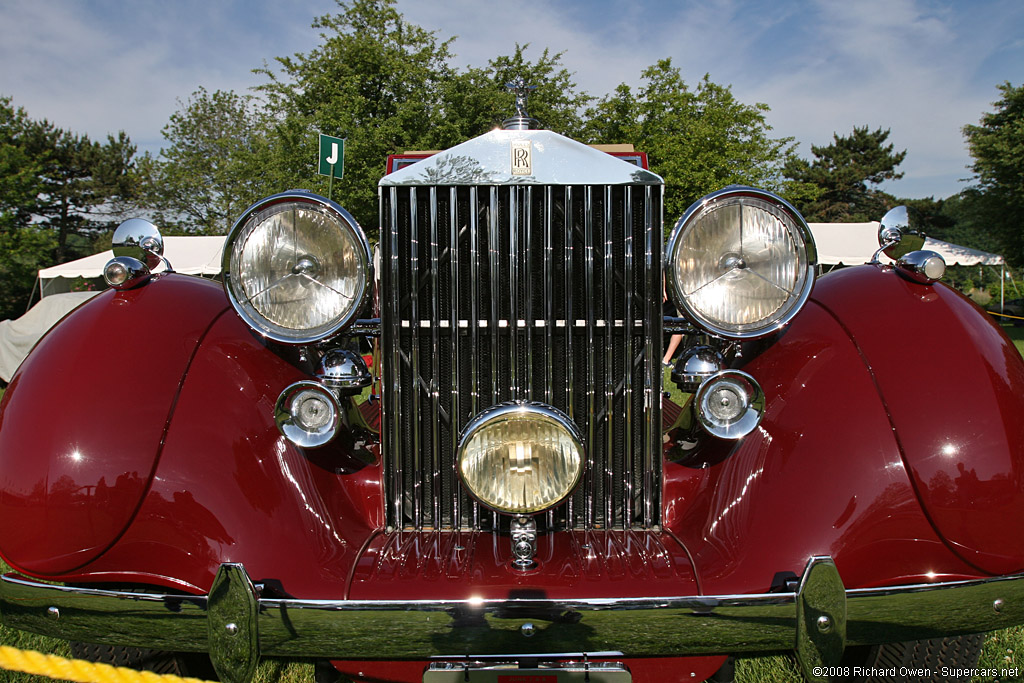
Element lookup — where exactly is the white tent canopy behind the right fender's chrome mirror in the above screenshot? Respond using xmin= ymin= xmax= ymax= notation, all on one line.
xmin=808 ymin=221 xmax=1004 ymax=265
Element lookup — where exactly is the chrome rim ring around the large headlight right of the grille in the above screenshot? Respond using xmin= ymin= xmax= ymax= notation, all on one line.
xmin=664 ymin=185 xmax=817 ymax=340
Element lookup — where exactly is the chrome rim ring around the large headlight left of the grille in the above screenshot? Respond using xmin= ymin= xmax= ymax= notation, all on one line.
xmin=220 ymin=189 xmax=373 ymax=346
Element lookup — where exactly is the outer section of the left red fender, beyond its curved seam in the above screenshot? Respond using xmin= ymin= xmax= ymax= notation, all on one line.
xmin=0 ymin=274 xmax=227 ymax=577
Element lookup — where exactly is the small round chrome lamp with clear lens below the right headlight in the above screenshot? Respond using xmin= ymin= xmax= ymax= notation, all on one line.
xmin=694 ymin=370 xmax=765 ymax=439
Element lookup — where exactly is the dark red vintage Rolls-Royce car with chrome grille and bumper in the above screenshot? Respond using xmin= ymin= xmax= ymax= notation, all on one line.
xmin=0 ymin=97 xmax=1024 ymax=683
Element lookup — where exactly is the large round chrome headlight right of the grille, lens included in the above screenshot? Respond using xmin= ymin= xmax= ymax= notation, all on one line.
xmin=666 ymin=186 xmax=817 ymax=339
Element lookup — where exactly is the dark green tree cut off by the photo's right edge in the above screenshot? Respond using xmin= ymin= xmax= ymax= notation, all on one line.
xmin=964 ymin=82 xmax=1024 ymax=265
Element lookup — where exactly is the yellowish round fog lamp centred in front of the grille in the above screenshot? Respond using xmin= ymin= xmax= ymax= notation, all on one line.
xmin=457 ymin=402 xmax=586 ymax=515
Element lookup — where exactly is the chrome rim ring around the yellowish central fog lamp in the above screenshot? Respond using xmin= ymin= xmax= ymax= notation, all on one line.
xmin=456 ymin=400 xmax=587 ymax=517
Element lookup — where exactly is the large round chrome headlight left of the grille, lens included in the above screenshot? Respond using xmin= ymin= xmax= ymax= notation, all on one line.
xmin=223 ymin=191 xmax=371 ymax=344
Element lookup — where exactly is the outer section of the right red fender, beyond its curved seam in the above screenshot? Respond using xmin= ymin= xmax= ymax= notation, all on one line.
xmin=814 ymin=266 xmax=1024 ymax=573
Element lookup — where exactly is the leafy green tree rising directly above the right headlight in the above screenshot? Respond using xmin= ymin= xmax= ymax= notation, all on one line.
xmin=584 ymin=59 xmax=793 ymax=220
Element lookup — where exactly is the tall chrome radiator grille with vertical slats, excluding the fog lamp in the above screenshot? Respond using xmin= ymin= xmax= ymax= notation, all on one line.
xmin=381 ymin=185 xmax=663 ymax=530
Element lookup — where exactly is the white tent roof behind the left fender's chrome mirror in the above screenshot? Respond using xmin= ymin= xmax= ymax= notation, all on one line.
xmin=39 ymin=236 xmax=224 ymax=297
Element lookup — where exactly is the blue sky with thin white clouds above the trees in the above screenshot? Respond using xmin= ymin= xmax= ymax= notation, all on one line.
xmin=0 ymin=0 xmax=1024 ymax=198
